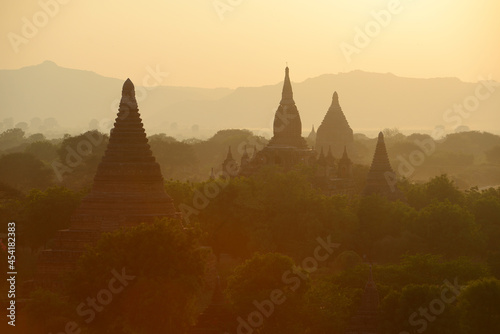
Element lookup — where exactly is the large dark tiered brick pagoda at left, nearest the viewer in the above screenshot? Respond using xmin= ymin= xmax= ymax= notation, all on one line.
xmin=37 ymin=79 xmax=178 ymax=286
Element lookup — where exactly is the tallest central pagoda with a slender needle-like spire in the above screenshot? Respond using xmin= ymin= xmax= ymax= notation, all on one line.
xmin=240 ymin=67 xmax=316 ymax=175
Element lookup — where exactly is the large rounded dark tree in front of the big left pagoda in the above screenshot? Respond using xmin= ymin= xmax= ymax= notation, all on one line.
xmin=69 ymin=220 xmax=205 ymax=334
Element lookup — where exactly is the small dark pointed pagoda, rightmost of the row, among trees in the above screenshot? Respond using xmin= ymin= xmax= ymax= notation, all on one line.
xmin=363 ymin=132 xmax=404 ymax=200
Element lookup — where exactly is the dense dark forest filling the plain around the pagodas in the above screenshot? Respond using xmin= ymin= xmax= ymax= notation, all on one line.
xmin=0 ymin=129 xmax=500 ymax=334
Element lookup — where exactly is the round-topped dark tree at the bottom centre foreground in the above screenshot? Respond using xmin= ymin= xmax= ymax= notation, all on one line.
xmin=227 ymin=253 xmax=309 ymax=334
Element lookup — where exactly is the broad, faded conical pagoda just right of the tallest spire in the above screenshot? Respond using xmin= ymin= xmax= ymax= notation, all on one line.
xmin=315 ymin=92 xmax=354 ymax=158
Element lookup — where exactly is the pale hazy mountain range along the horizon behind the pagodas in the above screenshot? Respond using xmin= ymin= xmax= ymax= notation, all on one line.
xmin=0 ymin=61 xmax=500 ymax=138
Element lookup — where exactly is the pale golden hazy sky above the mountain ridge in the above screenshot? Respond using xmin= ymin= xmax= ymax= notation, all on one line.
xmin=0 ymin=0 xmax=500 ymax=88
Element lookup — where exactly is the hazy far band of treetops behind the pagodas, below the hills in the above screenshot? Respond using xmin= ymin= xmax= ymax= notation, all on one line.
xmin=0 ymin=128 xmax=500 ymax=191
